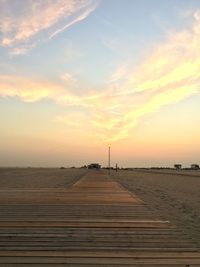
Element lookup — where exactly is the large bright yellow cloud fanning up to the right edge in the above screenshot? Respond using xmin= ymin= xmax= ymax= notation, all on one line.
xmin=99 ymin=11 xmax=200 ymax=141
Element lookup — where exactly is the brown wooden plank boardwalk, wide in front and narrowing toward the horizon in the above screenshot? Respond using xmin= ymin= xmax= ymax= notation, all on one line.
xmin=0 ymin=171 xmax=200 ymax=267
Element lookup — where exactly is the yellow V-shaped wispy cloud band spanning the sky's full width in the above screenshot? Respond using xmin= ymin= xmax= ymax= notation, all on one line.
xmin=0 ymin=9 xmax=200 ymax=143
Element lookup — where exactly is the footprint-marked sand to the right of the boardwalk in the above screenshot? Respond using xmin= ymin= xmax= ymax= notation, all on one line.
xmin=111 ymin=170 xmax=200 ymax=247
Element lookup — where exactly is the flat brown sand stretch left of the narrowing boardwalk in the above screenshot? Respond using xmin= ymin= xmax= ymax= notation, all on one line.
xmin=0 ymin=168 xmax=87 ymax=190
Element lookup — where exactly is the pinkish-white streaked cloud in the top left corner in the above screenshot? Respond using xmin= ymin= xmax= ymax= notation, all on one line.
xmin=0 ymin=0 xmax=98 ymax=55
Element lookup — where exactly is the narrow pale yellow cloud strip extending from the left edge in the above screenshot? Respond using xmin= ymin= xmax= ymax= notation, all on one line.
xmin=0 ymin=75 xmax=86 ymax=106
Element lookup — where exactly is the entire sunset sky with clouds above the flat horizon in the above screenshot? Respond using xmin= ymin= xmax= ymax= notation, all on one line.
xmin=0 ymin=0 xmax=200 ymax=167
